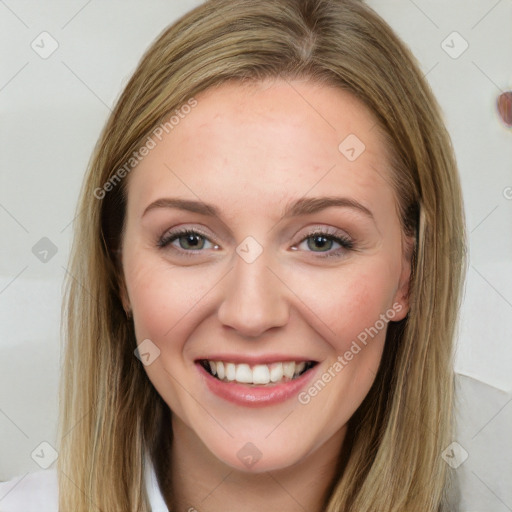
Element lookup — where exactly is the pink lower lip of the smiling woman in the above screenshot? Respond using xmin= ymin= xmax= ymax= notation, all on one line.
xmin=196 ymin=363 xmax=319 ymax=407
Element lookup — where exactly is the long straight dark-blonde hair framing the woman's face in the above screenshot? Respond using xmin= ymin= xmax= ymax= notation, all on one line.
xmin=58 ymin=0 xmax=466 ymax=512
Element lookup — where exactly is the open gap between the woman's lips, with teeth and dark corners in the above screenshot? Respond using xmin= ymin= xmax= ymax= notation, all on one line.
xmin=198 ymin=359 xmax=317 ymax=386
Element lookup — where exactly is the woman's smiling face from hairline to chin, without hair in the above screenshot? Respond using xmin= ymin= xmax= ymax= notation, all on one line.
xmin=123 ymin=80 xmax=410 ymax=472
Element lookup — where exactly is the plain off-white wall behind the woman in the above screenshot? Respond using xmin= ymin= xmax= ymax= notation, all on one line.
xmin=0 ymin=0 xmax=512 ymax=512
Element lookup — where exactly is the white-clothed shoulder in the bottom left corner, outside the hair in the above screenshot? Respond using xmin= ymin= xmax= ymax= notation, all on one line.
xmin=0 ymin=469 xmax=59 ymax=512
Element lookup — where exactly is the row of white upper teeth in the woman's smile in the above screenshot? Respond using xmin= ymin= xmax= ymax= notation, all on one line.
xmin=208 ymin=361 xmax=306 ymax=384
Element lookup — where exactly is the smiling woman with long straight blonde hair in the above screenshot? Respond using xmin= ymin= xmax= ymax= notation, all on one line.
xmin=0 ymin=0 xmax=465 ymax=512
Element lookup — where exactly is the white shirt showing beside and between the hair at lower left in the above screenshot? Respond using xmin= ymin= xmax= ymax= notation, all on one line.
xmin=0 ymin=450 xmax=169 ymax=512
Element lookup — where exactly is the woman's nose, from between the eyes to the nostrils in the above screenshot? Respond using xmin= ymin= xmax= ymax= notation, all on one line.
xmin=217 ymin=246 xmax=289 ymax=338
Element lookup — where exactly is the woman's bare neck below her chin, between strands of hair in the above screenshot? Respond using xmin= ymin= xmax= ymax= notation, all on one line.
xmin=165 ymin=417 xmax=346 ymax=512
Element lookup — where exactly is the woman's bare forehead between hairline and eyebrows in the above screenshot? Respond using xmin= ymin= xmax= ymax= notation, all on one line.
xmin=123 ymin=80 xmax=393 ymax=222
